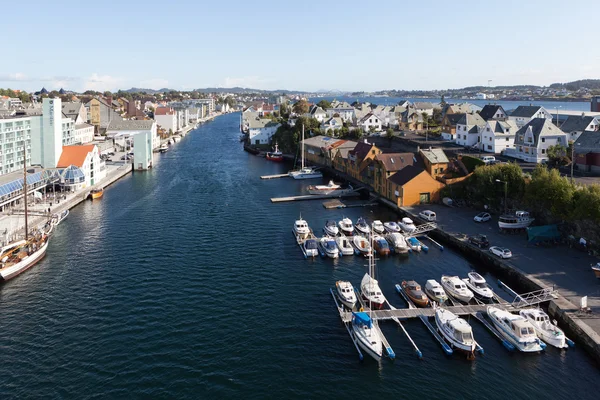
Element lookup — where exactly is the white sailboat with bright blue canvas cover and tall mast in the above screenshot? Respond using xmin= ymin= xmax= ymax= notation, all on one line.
xmin=352 ymin=230 xmax=385 ymax=361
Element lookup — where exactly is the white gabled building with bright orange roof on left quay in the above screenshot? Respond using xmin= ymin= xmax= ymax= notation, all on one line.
xmin=56 ymin=144 xmax=106 ymax=191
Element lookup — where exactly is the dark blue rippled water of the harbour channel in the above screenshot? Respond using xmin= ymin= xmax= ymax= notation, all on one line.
xmin=0 ymin=115 xmax=600 ymax=399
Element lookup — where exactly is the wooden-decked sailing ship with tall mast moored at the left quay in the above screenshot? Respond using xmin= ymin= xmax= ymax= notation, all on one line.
xmin=0 ymin=148 xmax=49 ymax=281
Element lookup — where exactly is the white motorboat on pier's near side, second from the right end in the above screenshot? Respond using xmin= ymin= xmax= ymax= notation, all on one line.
xmin=487 ymin=306 xmax=546 ymax=352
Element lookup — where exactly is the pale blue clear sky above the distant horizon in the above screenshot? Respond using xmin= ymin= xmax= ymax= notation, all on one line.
xmin=0 ymin=0 xmax=600 ymax=91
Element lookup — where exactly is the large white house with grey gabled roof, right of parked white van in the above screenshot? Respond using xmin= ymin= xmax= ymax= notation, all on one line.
xmin=505 ymin=118 xmax=568 ymax=162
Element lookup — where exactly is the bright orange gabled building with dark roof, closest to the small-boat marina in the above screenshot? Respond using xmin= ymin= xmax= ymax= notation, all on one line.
xmin=386 ymin=165 xmax=445 ymax=207
